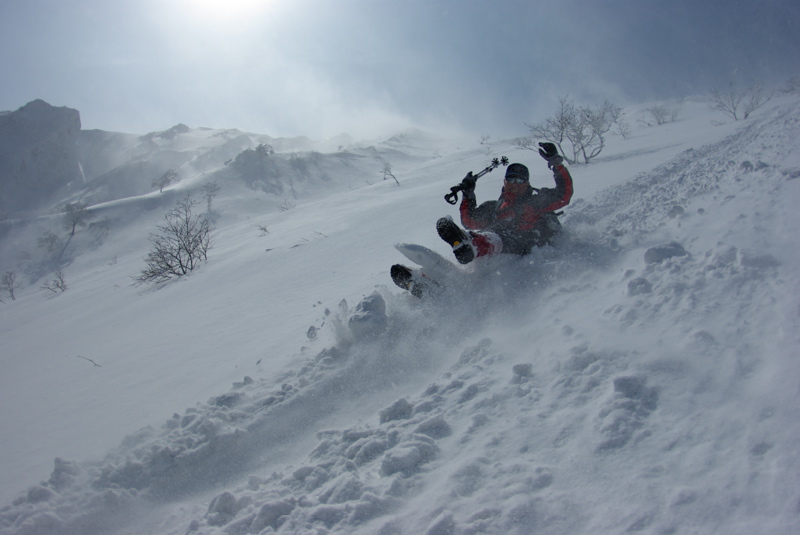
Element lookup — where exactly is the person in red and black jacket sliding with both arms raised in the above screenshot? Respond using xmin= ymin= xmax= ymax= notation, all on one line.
xmin=436 ymin=143 xmax=572 ymax=264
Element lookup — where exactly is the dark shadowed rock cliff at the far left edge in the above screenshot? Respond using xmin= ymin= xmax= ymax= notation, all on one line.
xmin=0 ymin=100 xmax=82 ymax=213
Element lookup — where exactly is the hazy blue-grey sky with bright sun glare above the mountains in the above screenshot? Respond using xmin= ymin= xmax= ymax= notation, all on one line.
xmin=0 ymin=0 xmax=800 ymax=138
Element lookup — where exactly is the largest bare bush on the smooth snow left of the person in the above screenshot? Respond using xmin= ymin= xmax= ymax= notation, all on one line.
xmin=133 ymin=196 xmax=212 ymax=284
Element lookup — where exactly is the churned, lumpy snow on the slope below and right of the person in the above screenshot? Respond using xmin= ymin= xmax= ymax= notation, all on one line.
xmin=0 ymin=99 xmax=800 ymax=535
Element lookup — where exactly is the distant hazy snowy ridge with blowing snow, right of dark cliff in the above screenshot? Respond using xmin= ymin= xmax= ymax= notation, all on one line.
xmin=69 ymin=124 xmax=443 ymax=211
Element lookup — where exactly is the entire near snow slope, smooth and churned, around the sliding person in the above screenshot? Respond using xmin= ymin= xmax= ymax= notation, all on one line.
xmin=0 ymin=98 xmax=800 ymax=535
